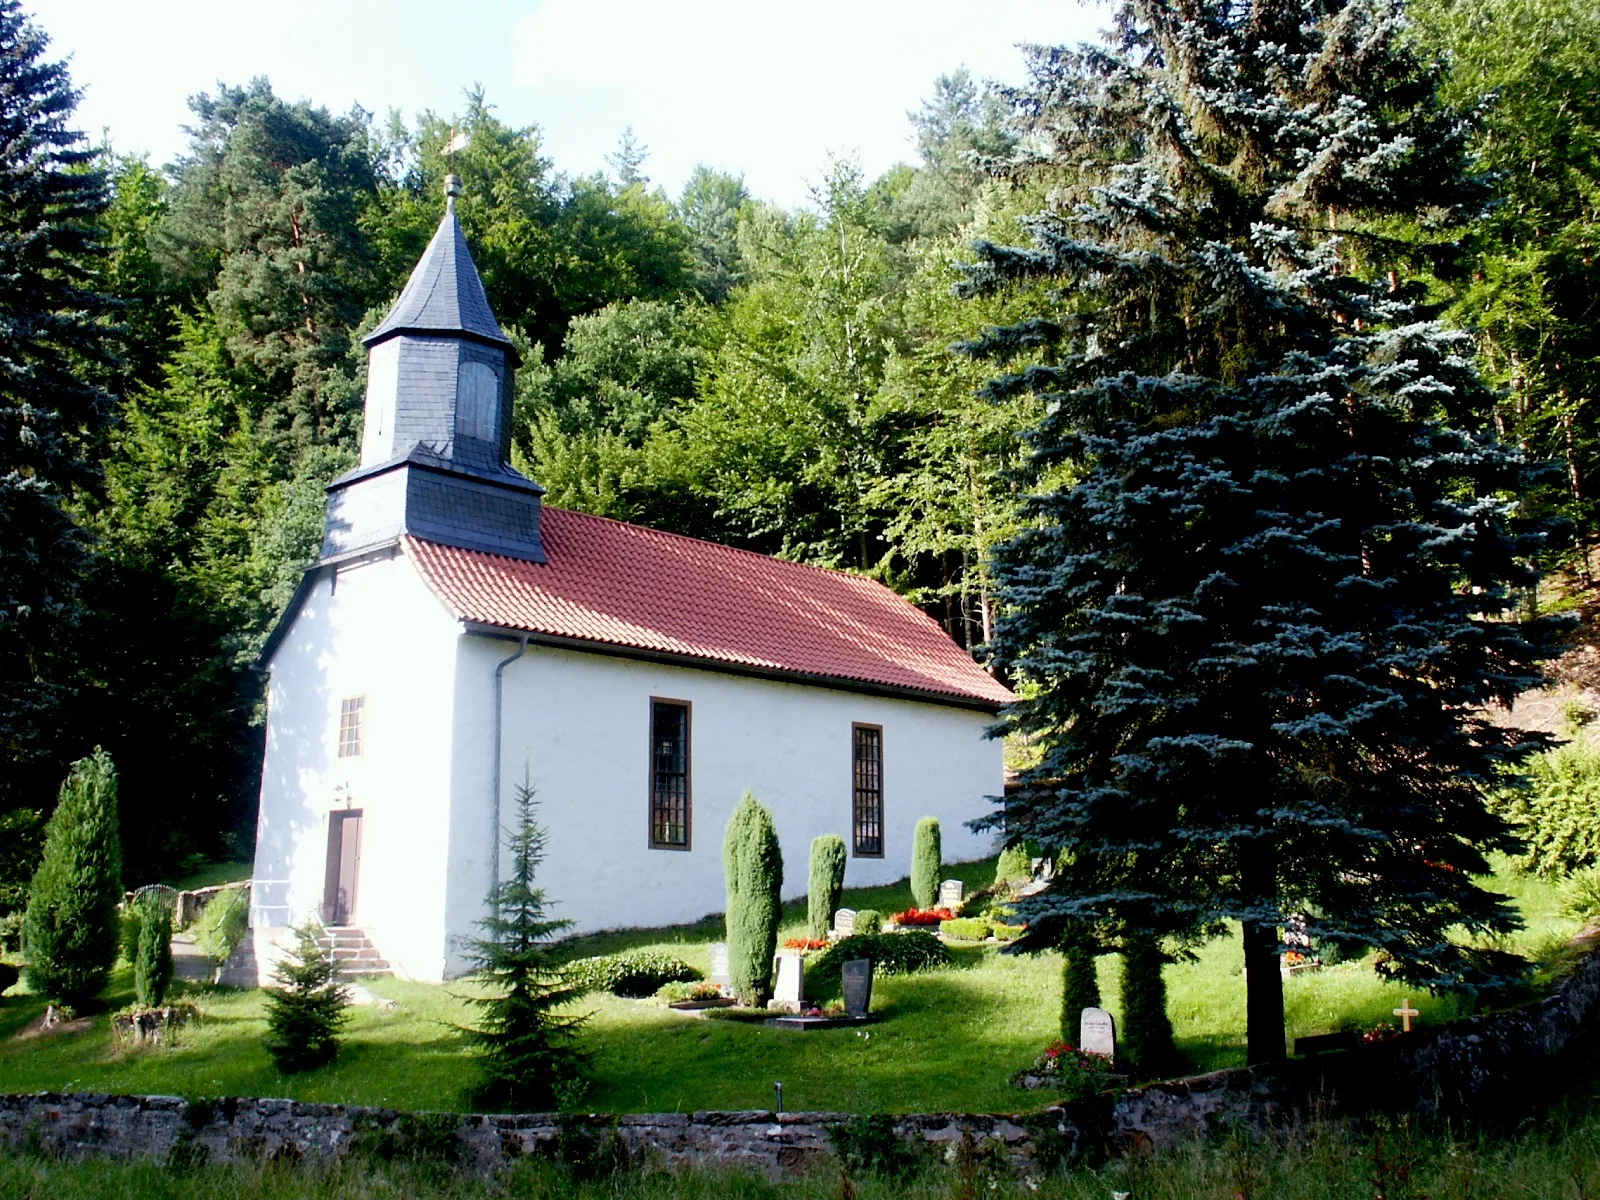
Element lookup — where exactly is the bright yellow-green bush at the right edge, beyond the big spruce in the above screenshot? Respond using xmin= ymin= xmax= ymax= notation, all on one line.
xmin=1491 ymin=738 xmax=1600 ymax=877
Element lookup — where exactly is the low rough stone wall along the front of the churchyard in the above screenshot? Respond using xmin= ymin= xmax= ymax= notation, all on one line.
xmin=0 ymin=934 xmax=1600 ymax=1176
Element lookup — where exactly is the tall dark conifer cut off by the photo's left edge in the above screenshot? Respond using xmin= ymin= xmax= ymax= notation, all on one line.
xmin=0 ymin=0 xmax=112 ymax=811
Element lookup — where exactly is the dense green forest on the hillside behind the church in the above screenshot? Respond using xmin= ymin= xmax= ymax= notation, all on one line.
xmin=0 ymin=0 xmax=1600 ymax=910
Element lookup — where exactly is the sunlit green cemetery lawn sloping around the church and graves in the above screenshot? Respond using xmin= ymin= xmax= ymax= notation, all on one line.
xmin=0 ymin=859 xmax=1578 ymax=1112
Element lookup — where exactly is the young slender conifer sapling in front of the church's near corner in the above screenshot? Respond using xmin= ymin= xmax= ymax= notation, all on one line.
xmin=467 ymin=781 xmax=586 ymax=1109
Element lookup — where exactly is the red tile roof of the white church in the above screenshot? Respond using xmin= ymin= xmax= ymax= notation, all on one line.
xmin=403 ymin=507 xmax=1014 ymax=709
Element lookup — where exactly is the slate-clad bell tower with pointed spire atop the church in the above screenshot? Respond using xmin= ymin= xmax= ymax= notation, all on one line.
xmin=322 ymin=174 xmax=546 ymax=563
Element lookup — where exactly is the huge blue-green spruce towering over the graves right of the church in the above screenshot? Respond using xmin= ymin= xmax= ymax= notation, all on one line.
xmin=966 ymin=0 xmax=1550 ymax=1062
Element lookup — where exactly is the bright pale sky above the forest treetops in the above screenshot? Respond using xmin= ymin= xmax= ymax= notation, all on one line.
xmin=24 ymin=0 xmax=1106 ymax=205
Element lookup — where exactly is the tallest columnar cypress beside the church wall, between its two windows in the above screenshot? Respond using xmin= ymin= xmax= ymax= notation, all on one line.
xmin=722 ymin=792 xmax=784 ymax=1006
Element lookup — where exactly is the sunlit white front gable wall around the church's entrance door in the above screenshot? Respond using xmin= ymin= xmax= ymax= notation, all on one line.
xmin=251 ymin=555 xmax=461 ymax=979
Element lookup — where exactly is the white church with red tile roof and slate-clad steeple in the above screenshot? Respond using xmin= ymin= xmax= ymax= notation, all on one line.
xmin=250 ymin=183 xmax=1011 ymax=981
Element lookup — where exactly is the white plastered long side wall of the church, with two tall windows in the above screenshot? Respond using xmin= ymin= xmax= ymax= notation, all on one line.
xmin=448 ymin=635 xmax=1003 ymax=970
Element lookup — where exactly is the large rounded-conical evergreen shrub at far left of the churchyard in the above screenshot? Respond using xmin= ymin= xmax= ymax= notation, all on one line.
xmin=22 ymin=749 xmax=122 ymax=1005
